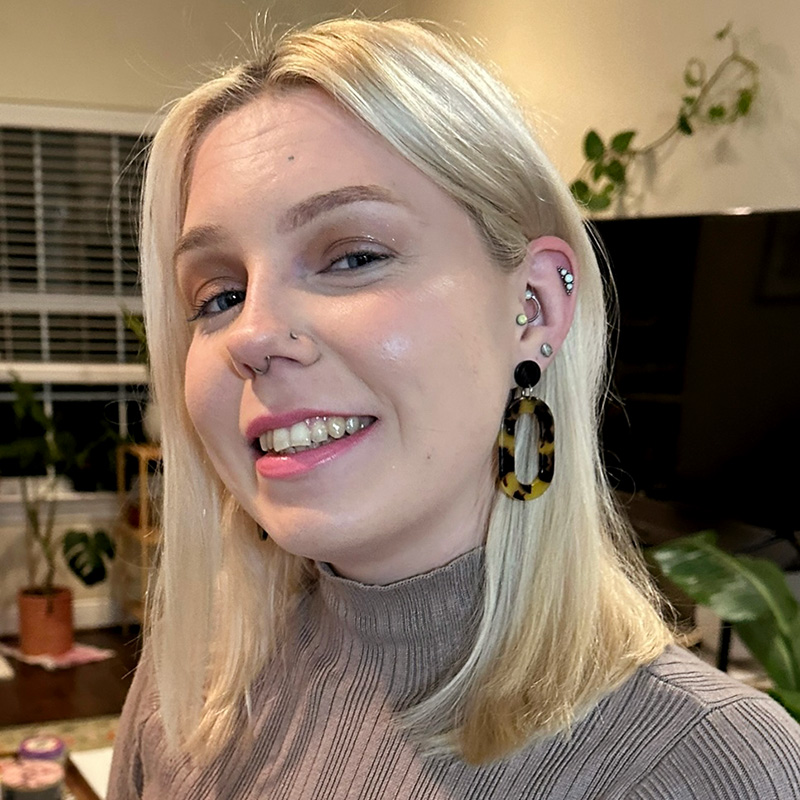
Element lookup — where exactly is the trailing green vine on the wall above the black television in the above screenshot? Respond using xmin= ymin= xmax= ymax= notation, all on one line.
xmin=570 ymin=23 xmax=759 ymax=211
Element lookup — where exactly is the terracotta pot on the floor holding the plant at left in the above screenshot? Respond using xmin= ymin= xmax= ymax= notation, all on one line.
xmin=17 ymin=586 xmax=73 ymax=656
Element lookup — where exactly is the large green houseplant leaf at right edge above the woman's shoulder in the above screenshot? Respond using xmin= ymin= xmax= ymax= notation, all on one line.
xmin=648 ymin=531 xmax=800 ymax=721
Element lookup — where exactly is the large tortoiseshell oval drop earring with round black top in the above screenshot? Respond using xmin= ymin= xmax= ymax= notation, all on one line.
xmin=497 ymin=361 xmax=555 ymax=500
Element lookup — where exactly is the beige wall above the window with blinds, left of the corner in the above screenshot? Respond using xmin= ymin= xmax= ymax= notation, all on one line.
xmin=0 ymin=0 xmax=403 ymax=112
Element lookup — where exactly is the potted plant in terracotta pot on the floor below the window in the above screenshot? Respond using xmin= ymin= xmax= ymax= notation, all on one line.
xmin=0 ymin=377 xmax=114 ymax=655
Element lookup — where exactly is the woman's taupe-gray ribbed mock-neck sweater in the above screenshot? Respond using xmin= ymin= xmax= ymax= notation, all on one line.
xmin=108 ymin=551 xmax=800 ymax=800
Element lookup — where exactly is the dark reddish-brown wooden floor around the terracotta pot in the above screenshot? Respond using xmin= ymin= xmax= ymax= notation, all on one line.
xmin=0 ymin=628 xmax=139 ymax=727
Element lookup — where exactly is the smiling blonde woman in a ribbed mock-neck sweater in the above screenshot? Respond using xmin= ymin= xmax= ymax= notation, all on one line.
xmin=109 ymin=15 xmax=800 ymax=800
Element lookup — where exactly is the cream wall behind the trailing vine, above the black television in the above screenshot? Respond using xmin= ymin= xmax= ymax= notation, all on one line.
xmin=407 ymin=0 xmax=800 ymax=215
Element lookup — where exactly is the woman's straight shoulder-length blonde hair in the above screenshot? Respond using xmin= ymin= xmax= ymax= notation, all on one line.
xmin=141 ymin=19 xmax=670 ymax=763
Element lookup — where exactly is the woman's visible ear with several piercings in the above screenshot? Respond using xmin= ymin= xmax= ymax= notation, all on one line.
xmin=517 ymin=231 xmax=580 ymax=371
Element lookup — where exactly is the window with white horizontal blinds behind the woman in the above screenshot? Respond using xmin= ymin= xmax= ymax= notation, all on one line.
xmin=0 ymin=126 xmax=145 ymax=384
